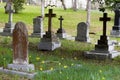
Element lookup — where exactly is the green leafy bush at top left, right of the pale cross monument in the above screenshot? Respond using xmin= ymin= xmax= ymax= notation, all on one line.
xmin=13 ymin=0 xmax=25 ymax=13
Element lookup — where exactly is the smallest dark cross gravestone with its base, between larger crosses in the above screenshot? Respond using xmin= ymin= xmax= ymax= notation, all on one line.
xmin=56 ymin=16 xmax=66 ymax=38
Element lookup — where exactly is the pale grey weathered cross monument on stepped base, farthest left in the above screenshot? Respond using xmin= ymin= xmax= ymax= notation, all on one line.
xmin=2 ymin=0 xmax=14 ymax=35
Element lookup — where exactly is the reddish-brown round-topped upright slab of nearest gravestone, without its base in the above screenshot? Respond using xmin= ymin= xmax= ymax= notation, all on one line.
xmin=13 ymin=22 xmax=28 ymax=64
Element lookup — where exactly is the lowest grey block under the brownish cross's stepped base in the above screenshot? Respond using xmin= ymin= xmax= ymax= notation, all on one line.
xmin=38 ymin=42 xmax=61 ymax=51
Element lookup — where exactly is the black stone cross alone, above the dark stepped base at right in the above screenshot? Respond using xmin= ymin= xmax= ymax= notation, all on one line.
xmin=99 ymin=13 xmax=110 ymax=36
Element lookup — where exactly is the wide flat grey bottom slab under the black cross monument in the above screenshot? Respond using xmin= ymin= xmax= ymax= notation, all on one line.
xmin=84 ymin=51 xmax=120 ymax=60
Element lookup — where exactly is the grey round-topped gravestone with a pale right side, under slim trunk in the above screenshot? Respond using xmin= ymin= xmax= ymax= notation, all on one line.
xmin=75 ymin=22 xmax=90 ymax=42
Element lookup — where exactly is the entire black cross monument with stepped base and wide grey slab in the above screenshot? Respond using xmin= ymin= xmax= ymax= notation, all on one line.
xmin=84 ymin=13 xmax=120 ymax=59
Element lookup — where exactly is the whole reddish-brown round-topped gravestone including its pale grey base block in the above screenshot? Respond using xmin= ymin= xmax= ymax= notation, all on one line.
xmin=8 ymin=22 xmax=34 ymax=72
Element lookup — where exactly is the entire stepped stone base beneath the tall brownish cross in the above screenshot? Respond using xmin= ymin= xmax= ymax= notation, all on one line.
xmin=38 ymin=31 xmax=61 ymax=51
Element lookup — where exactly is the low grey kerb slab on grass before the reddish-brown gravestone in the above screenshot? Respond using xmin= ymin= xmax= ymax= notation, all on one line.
xmin=0 ymin=67 xmax=37 ymax=79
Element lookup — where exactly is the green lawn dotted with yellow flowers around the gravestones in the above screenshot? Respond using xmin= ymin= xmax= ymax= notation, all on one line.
xmin=0 ymin=4 xmax=120 ymax=80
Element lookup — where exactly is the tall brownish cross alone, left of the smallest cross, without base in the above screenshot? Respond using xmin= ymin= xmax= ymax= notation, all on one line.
xmin=45 ymin=9 xmax=56 ymax=32
